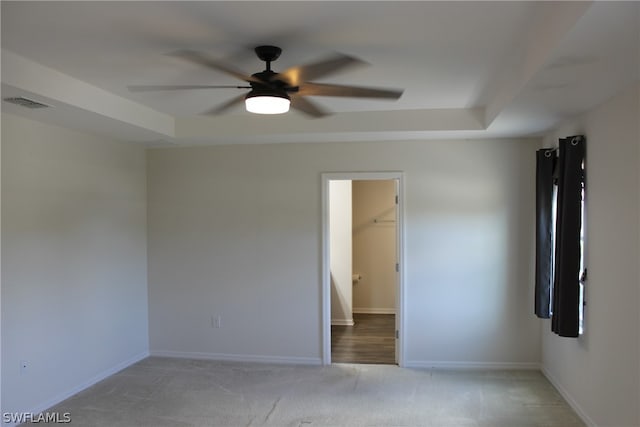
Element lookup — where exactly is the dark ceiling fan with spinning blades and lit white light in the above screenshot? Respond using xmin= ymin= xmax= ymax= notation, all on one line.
xmin=128 ymin=46 xmax=403 ymax=117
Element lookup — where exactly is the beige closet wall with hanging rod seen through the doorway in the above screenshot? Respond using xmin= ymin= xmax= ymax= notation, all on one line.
xmin=353 ymin=180 xmax=397 ymax=314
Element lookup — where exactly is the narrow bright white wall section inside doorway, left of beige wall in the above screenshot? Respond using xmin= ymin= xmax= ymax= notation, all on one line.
xmin=329 ymin=180 xmax=353 ymax=325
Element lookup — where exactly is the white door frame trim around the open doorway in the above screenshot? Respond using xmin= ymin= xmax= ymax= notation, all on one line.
xmin=322 ymin=172 xmax=405 ymax=367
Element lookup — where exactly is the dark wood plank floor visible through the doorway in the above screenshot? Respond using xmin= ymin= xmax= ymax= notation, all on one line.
xmin=331 ymin=314 xmax=396 ymax=364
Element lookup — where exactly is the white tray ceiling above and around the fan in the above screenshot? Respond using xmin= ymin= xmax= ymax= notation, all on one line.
xmin=1 ymin=1 xmax=640 ymax=145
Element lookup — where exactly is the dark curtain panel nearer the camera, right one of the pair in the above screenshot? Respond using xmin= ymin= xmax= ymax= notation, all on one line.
xmin=551 ymin=136 xmax=585 ymax=337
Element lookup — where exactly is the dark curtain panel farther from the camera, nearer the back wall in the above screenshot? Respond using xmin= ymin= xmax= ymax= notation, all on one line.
xmin=535 ymin=148 xmax=558 ymax=319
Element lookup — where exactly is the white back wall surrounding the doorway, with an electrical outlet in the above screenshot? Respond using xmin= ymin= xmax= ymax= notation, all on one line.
xmin=147 ymin=139 xmax=540 ymax=366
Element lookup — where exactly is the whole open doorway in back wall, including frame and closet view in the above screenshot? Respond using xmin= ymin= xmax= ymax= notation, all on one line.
xmin=322 ymin=172 xmax=404 ymax=366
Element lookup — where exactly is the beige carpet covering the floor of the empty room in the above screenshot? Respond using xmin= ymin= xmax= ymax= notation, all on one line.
xmin=35 ymin=357 xmax=583 ymax=427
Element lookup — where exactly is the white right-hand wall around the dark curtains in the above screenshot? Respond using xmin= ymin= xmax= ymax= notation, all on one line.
xmin=542 ymin=86 xmax=640 ymax=427
